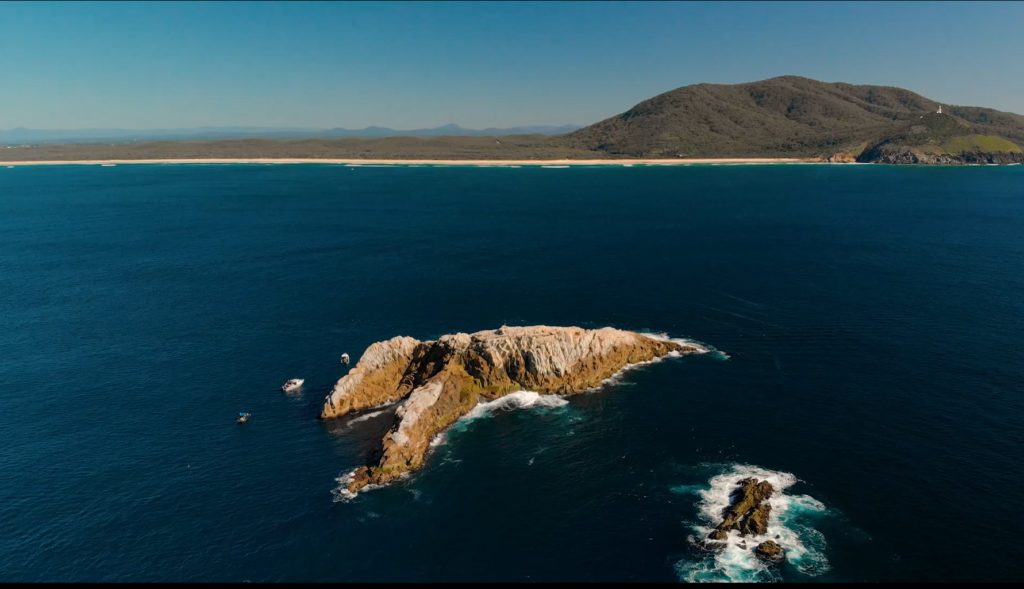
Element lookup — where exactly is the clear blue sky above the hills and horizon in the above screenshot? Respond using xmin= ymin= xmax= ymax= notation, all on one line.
xmin=0 ymin=2 xmax=1024 ymax=129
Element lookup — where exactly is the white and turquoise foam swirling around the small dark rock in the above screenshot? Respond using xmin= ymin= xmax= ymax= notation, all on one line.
xmin=671 ymin=464 xmax=829 ymax=583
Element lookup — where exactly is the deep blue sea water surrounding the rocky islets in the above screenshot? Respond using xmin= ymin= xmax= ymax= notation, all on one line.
xmin=0 ymin=165 xmax=1024 ymax=581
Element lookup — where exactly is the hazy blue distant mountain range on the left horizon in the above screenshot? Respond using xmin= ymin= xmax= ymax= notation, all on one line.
xmin=0 ymin=125 xmax=581 ymax=145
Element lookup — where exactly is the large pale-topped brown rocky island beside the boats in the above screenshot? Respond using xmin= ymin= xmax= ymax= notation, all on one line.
xmin=321 ymin=326 xmax=702 ymax=493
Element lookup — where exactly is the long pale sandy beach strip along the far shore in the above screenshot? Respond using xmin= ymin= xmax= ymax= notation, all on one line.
xmin=0 ymin=158 xmax=821 ymax=167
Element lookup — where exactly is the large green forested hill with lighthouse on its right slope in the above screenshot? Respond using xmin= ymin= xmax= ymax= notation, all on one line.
xmin=555 ymin=76 xmax=1024 ymax=163
